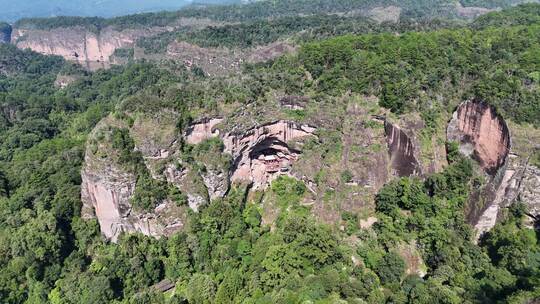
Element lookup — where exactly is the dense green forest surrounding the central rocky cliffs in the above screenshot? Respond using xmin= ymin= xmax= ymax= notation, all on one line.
xmin=0 ymin=1 xmax=540 ymax=303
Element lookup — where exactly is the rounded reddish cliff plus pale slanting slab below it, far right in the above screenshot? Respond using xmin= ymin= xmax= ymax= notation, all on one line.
xmin=447 ymin=100 xmax=540 ymax=238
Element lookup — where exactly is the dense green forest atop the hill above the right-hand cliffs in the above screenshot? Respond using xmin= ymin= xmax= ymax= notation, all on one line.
xmin=288 ymin=25 xmax=540 ymax=125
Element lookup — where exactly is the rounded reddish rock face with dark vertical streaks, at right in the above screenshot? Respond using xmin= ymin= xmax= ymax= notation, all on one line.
xmin=447 ymin=100 xmax=510 ymax=175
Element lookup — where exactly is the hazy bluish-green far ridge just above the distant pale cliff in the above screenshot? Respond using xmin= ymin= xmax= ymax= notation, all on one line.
xmin=15 ymin=0 xmax=532 ymax=30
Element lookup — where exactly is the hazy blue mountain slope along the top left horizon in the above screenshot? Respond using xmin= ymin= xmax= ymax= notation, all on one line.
xmin=0 ymin=0 xmax=236 ymax=22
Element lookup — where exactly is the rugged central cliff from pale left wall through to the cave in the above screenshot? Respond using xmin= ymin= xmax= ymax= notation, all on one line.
xmin=81 ymin=111 xmax=315 ymax=241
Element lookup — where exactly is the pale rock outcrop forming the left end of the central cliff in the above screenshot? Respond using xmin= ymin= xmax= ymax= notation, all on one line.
xmin=81 ymin=117 xmax=186 ymax=242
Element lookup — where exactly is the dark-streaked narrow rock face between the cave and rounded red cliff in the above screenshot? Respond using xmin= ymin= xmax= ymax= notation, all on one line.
xmin=384 ymin=121 xmax=421 ymax=176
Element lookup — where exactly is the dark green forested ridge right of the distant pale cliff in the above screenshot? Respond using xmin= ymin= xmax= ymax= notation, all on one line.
xmin=137 ymin=15 xmax=458 ymax=53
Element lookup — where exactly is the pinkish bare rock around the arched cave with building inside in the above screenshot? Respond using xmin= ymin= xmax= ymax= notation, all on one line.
xmin=223 ymin=121 xmax=315 ymax=189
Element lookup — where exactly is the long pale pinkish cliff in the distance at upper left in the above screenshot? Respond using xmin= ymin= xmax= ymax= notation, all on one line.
xmin=12 ymin=26 xmax=165 ymax=69
